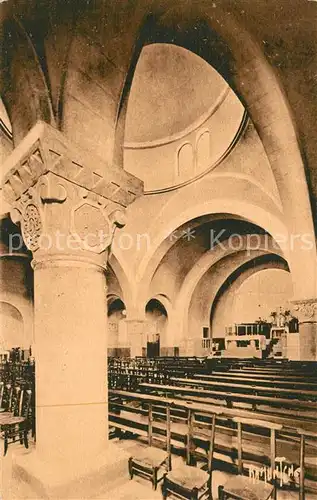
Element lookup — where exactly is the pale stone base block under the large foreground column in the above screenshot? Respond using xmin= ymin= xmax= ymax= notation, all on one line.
xmin=3 ymin=443 xmax=129 ymax=500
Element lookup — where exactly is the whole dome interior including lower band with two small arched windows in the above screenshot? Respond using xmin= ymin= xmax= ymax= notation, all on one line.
xmin=124 ymin=44 xmax=245 ymax=193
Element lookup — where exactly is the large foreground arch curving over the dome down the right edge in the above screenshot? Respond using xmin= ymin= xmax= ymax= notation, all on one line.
xmin=111 ymin=2 xmax=317 ymax=297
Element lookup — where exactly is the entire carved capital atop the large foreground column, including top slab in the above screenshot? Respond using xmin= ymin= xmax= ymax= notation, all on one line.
xmin=2 ymin=122 xmax=143 ymax=268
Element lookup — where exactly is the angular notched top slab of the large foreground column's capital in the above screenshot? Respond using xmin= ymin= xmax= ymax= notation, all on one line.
xmin=2 ymin=122 xmax=143 ymax=207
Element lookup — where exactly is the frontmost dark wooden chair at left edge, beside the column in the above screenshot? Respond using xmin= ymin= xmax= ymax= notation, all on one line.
xmin=0 ymin=388 xmax=32 ymax=455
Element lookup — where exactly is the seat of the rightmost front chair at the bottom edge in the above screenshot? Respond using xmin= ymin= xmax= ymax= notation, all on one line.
xmin=224 ymin=476 xmax=273 ymax=500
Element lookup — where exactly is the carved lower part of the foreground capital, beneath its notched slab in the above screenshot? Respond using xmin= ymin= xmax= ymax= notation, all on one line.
xmin=11 ymin=172 xmax=125 ymax=254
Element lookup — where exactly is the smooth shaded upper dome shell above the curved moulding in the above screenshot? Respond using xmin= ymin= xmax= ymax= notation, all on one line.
xmin=125 ymin=43 xmax=228 ymax=143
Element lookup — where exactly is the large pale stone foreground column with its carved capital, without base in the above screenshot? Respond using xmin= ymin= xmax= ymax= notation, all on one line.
xmin=3 ymin=123 xmax=142 ymax=498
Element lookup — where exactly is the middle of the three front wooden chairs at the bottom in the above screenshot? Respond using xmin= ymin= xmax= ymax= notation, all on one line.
xmin=162 ymin=409 xmax=216 ymax=500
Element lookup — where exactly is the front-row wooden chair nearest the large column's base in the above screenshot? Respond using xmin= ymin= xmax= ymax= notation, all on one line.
xmin=129 ymin=403 xmax=171 ymax=490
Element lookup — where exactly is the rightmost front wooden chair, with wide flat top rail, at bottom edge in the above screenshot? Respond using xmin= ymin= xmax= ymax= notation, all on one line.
xmin=218 ymin=417 xmax=283 ymax=500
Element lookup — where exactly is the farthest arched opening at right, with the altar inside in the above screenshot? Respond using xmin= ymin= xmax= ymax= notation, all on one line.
xmin=210 ymin=254 xmax=295 ymax=358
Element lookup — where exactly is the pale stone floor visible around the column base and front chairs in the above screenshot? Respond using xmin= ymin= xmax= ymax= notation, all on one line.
xmin=0 ymin=439 xmax=317 ymax=500
